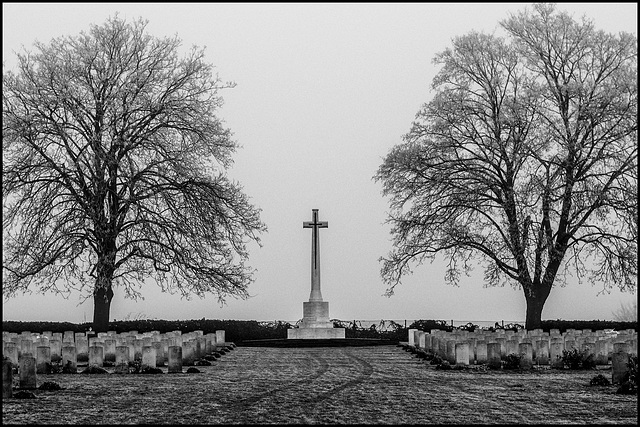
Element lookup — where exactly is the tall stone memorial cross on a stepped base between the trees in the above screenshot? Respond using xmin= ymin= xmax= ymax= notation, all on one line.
xmin=287 ymin=209 xmax=345 ymax=339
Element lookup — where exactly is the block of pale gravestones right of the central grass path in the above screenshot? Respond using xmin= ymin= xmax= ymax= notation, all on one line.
xmin=406 ymin=329 xmax=638 ymax=384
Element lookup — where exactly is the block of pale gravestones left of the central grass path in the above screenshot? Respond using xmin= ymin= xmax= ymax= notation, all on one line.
xmin=2 ymin=330 xmax=235 ymax=398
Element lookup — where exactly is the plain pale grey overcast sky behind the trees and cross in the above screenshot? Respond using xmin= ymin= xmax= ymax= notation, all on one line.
xmin=2 ymin=3 xmax=637 ymax=322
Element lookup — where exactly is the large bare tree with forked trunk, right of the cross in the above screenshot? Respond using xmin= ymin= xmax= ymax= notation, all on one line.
xmin=374 ymin=4 xmax=638 ymax=329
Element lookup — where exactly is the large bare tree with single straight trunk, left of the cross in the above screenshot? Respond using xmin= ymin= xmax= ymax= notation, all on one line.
xmin=2 ymin=16 xmax=266 ymax=331
